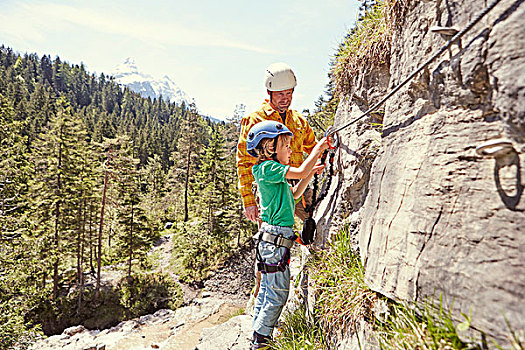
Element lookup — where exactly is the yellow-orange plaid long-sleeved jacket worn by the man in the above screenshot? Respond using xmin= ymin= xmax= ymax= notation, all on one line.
xmin=237 ymin=100 xmax=317 ymax=208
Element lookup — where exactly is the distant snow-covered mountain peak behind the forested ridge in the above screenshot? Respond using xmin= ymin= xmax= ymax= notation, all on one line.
xmin=111 ymin=57 xmax=192 ymax=105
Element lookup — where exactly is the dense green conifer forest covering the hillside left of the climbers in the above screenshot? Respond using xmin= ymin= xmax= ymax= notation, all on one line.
xmin=0 ymin=46 xmax=253 ymax=345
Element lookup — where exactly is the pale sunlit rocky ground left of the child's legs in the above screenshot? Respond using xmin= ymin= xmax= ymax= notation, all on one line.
xmin=31 ymin=236 xmax=260 ymax=350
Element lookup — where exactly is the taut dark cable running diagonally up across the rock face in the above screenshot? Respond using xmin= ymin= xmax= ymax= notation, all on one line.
xmin=328 ymin=0 xmax=501 ymax=135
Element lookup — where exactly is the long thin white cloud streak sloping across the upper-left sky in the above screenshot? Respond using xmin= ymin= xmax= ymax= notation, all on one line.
xmin=0 ymin=2 xmax=273 ymax=53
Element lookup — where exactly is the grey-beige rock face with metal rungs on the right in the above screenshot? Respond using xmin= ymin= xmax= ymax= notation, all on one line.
xmin=316 ymin=0 xmax=525 ymax=344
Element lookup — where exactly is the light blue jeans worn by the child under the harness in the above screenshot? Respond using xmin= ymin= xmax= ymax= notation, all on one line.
xmin=252 ymin=222 xmax=294 ymax=336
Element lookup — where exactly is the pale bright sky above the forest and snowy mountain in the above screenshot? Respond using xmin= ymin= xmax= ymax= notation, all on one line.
xmin=0 ymin=0 xmax=360 ymax=120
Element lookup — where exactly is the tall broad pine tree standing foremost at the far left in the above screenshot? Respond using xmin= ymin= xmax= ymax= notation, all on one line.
xmin=30 ymin=98 xmax=88 ymax=298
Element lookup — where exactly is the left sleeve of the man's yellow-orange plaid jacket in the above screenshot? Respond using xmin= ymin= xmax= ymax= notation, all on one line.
xmin=236 ymin=115 xmax=257 ymax=208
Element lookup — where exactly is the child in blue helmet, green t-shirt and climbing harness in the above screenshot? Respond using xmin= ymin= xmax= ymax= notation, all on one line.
xmin=247 ymin=120 xmax=328 ymax=349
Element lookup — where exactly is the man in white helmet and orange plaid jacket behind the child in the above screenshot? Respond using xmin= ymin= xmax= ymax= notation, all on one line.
xmin=237 ymin=62 xmax=317 ymax=222
